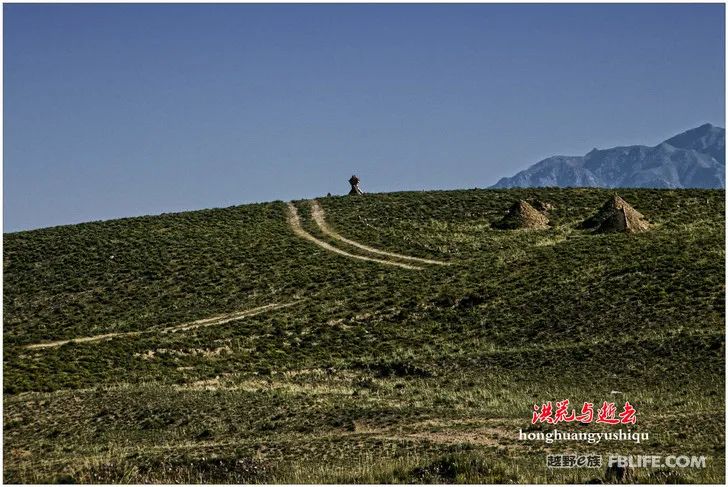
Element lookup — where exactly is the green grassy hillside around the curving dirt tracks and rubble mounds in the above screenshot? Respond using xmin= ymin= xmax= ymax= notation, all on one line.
xmin=3 ymin=189 xmax=725 ymax=483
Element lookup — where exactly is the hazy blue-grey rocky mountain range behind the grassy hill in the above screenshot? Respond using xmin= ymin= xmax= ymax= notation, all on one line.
xmin=492 ymin=123 xmax=725 ymax=188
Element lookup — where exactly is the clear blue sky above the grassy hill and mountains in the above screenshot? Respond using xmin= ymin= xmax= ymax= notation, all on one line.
xmin=4 ymin=4 xmax=725 ymax=232
